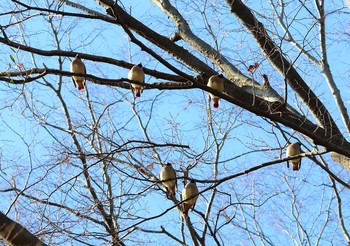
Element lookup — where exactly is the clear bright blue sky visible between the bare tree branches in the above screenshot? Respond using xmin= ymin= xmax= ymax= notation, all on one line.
xmin=0 ymin=1 xmax=350 ymax=245
